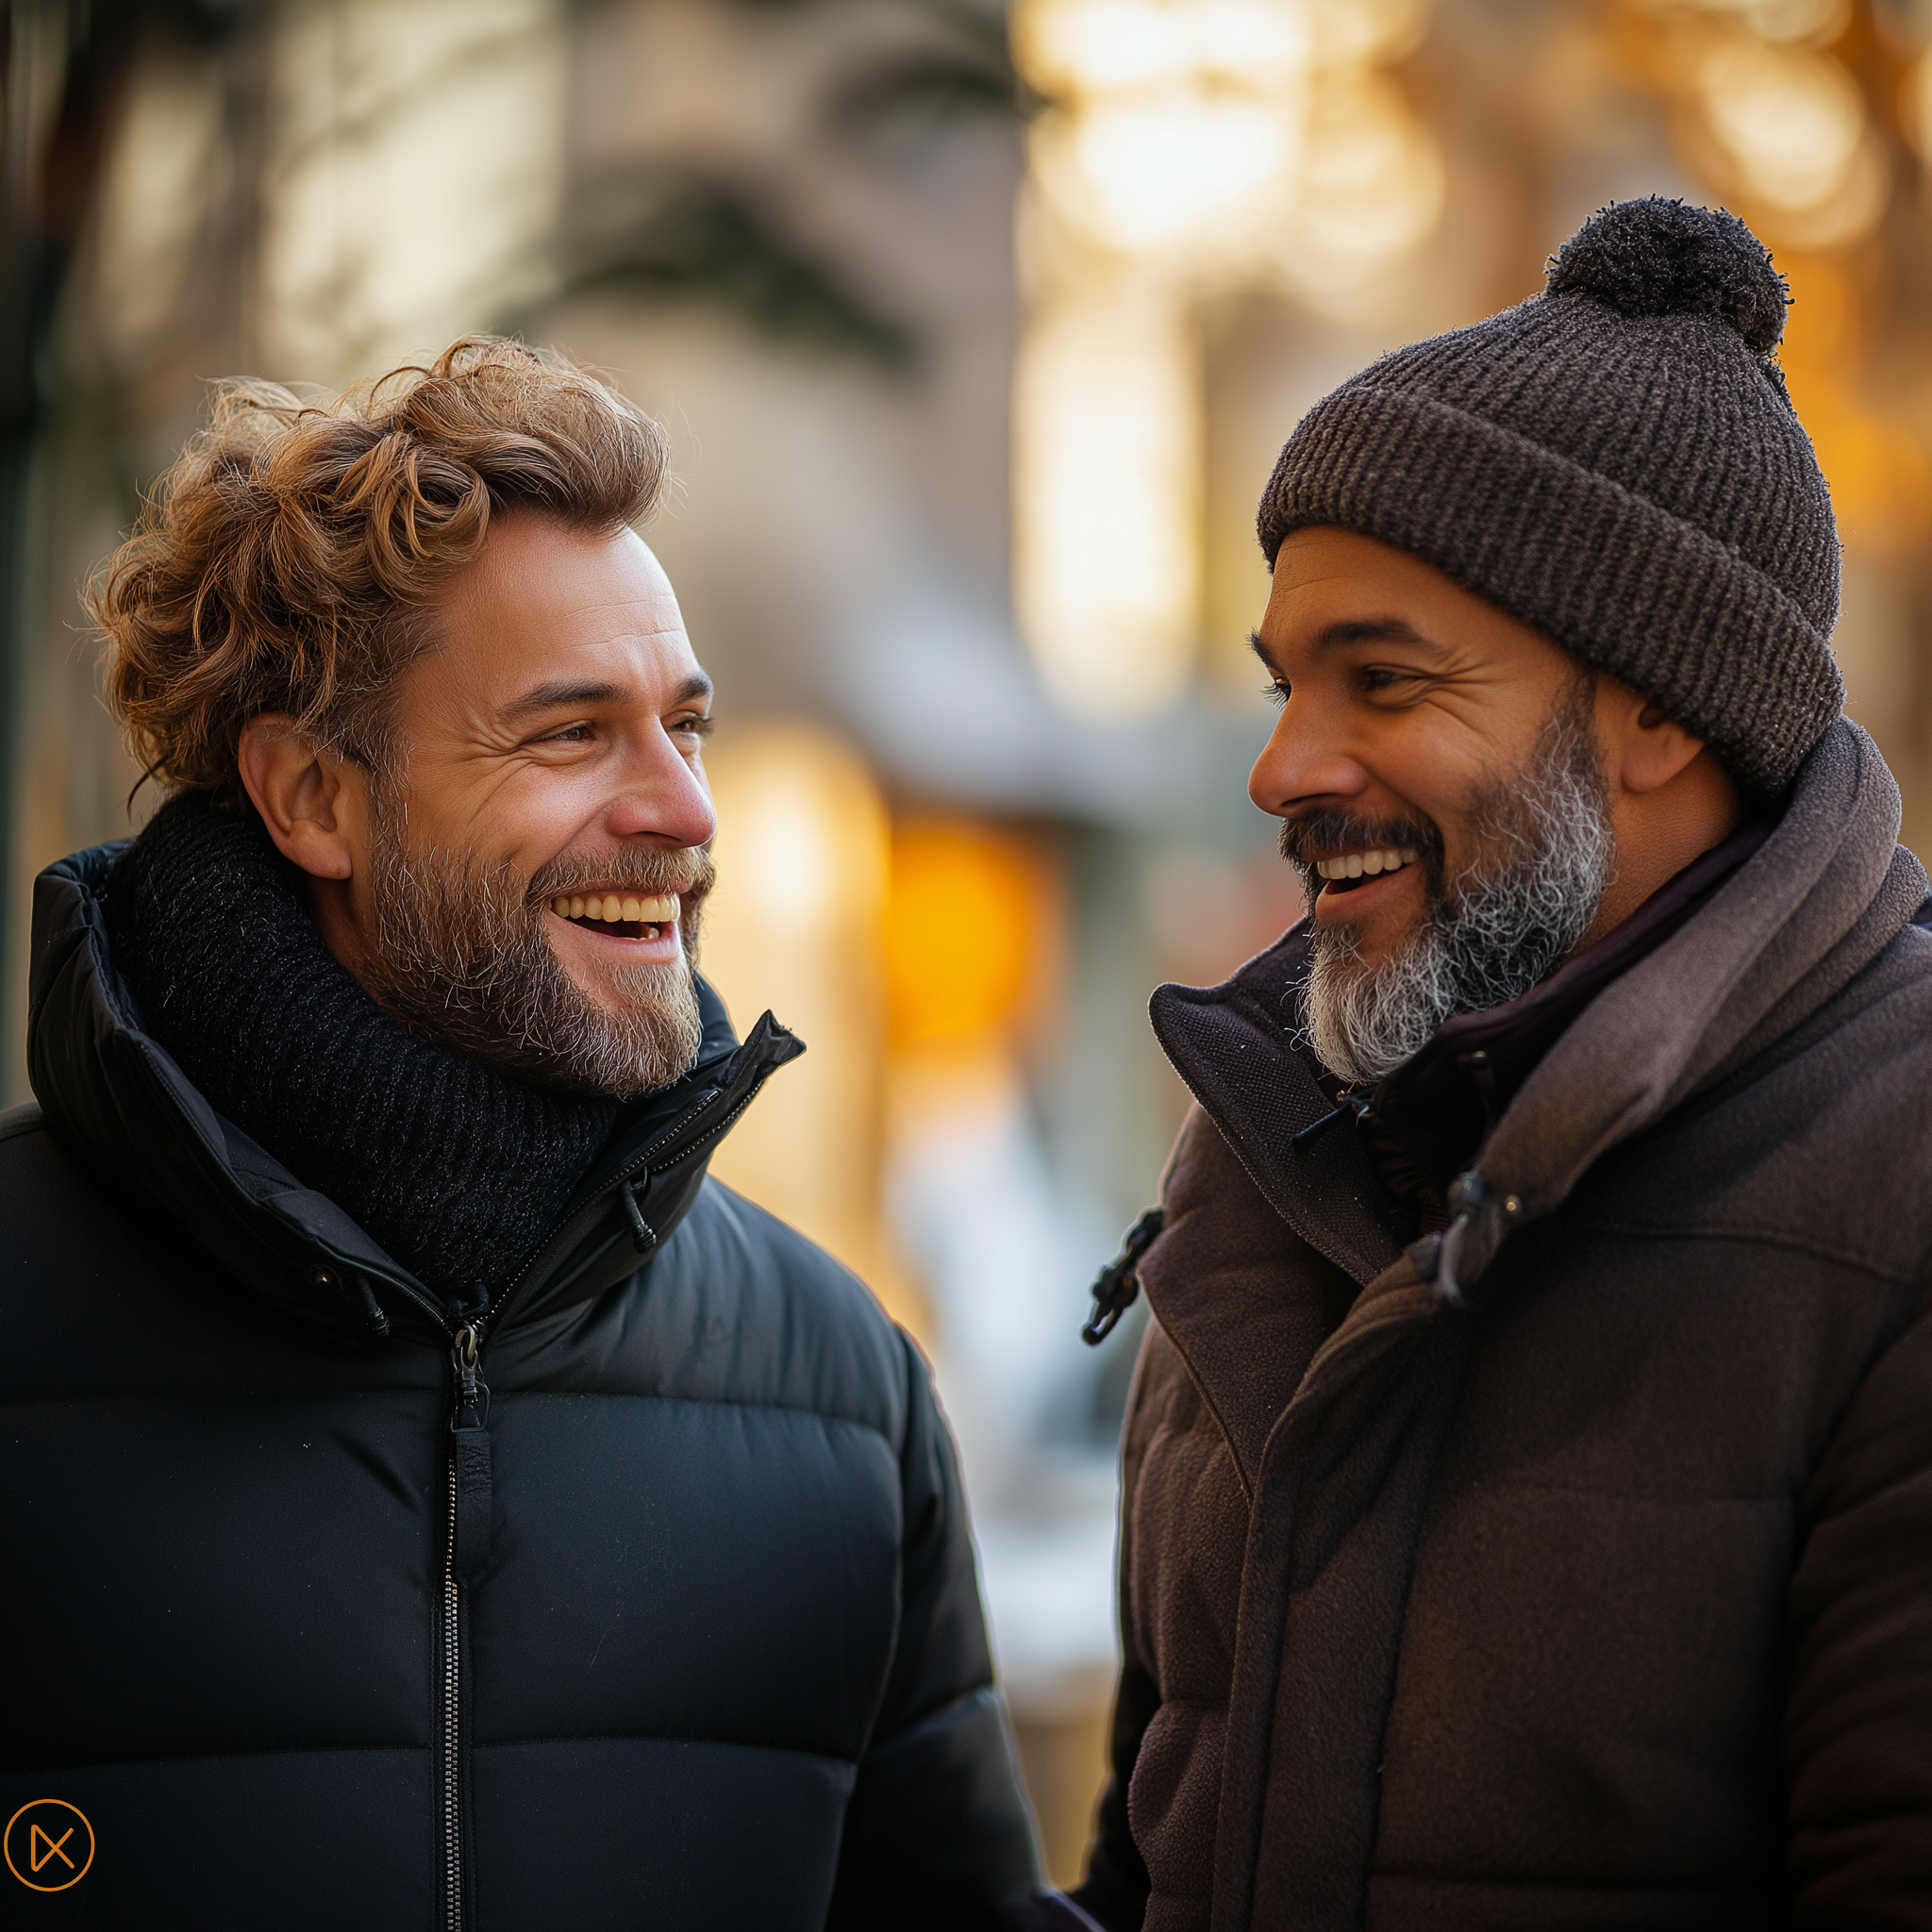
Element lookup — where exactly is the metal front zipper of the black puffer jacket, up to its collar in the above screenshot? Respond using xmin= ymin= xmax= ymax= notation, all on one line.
xmin=426 ymin=1066 xmax=771 ymax=1932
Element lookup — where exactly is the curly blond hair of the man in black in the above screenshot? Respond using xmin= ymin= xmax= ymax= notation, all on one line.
xmin=85 ymin=336 xmax=667 ymax=804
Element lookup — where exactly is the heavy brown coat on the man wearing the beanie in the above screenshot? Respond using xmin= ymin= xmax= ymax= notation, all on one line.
xmin=1078 ymin=724 xmax=1932 ymax=1932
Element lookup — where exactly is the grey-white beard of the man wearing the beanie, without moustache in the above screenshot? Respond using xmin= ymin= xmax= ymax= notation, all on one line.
xmin=1306 ymin=684 xmax=1615 ymax=1088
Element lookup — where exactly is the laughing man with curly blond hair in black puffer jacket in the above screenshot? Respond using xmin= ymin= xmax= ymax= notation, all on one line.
xmin=0 ymin=340 xmax=1036 ymax=1932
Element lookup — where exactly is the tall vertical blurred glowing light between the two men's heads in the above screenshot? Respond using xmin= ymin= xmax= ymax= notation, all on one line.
xmin=1014 ymin=291 xmax=1200 ymax=719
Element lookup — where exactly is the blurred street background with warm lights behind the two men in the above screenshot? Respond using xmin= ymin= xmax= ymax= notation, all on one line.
xmin=0 ymin=0 xmax=1932 ymax=1880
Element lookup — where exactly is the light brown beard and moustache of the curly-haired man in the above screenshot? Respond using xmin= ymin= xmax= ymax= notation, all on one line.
xmin=355 ymin=800 xmax=711 ymax=1099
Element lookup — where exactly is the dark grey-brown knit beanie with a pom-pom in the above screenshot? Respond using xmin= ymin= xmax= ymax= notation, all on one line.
xmin=1259 ymin=197 xmax=1845 ymax=800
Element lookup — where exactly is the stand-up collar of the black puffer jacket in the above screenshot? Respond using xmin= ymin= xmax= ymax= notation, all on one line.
xmin=27 ymin=844 xmax=804 ymax=1341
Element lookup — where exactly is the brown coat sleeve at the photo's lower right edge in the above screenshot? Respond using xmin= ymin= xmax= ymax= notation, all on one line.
xmin=1785 ymin=1291 xmax=1932 ymax=1932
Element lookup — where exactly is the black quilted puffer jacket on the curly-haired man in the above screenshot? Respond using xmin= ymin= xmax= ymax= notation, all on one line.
xmin=0 ymin=848 xmax=1036 ymax=1932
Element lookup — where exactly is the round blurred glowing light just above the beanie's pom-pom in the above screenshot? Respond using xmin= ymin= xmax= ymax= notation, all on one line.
xmin=1698 ymin=39 xmax=1864 ymax=208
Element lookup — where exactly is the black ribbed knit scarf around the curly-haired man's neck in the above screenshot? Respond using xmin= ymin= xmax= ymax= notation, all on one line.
xmin=107 ymin=796 xmax=618 ymax=1304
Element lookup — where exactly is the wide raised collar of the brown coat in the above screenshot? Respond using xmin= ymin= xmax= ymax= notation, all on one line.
xmin=1152 ymin=719 xmax=1926 ymax=1322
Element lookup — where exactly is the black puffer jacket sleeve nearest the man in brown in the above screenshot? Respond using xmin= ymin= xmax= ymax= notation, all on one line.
xmin=824 ymin=1337 xmax=1041 ymax=1932
